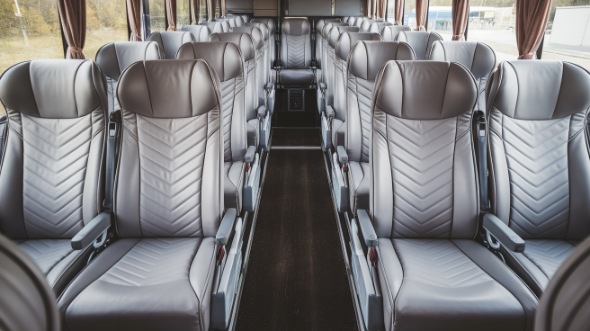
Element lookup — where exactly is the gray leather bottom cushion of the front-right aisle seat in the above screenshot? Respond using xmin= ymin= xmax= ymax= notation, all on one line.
xmin=379 ymin=239 xmax=537 ymax=331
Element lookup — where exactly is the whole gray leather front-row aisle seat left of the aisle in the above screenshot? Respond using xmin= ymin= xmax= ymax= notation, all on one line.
xmin=58 ymin=60 xmax=241 ymax=331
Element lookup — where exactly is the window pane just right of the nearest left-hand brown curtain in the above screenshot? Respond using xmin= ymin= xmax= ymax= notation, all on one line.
xmin=84 ymin=0 xmax=129 ymax=59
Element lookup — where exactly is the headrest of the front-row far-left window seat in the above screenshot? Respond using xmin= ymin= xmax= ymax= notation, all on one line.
xmin=0 ymin=60 xmax=108 ymax=119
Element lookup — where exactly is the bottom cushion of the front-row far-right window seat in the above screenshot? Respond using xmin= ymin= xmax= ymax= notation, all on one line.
xmin=504 ymin=239 xmax=576 ymax=297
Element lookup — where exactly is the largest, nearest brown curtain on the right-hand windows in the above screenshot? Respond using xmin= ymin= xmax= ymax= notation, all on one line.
xmin=516 ymin=0 xmax=551 ymax=59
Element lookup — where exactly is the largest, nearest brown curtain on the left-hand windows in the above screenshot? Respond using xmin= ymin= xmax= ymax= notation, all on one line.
xmin=58 ymin=0 xmax=86 ymax=59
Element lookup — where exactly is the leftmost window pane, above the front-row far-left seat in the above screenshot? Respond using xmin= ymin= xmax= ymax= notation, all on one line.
xmin=0 ymin=0 xmax=64 ymax=115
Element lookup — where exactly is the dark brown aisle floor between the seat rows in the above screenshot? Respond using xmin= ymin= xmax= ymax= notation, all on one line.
xmin=236 ymin=149 xmax=357 ymax=331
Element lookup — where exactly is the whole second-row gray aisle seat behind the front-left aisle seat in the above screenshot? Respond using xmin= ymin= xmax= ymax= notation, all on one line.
xmin=177 ymin=42 xmax=260 ymax=211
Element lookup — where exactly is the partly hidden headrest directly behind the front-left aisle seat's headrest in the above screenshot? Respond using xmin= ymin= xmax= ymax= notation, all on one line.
xmin=176 ymin=41 xmax=243 ymax=82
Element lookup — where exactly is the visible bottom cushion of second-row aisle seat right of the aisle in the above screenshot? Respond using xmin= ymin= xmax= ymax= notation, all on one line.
xmin=348 ymin=161 xmax=371 ymax=213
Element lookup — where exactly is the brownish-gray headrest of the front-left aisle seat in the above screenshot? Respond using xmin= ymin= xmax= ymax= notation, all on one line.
xmin=117 ymin=60 xmax=220 ymax=118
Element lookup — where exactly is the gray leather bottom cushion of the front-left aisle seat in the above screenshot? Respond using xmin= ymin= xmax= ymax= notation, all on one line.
xmin=58 ymin=238 xmax=215 ymax=331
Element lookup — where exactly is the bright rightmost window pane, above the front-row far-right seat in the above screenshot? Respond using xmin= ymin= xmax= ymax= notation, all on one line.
xmin=541 ymin=0 xmax=590 ymax=70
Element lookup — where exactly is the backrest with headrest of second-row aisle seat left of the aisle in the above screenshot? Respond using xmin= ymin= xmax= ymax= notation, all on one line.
xmin=177 ymin=42 xmax=247 ymax=162
